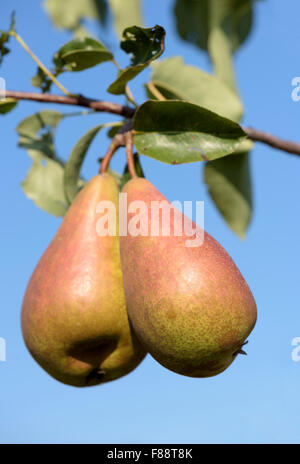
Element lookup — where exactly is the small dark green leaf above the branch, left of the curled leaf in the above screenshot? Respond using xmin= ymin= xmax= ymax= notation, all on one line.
xmin=54 ymin=37 xmax=113 ymax=72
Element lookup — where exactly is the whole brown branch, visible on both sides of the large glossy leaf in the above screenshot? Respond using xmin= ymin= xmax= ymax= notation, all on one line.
xmin=5 ymin=90 xmax=300 ymax=160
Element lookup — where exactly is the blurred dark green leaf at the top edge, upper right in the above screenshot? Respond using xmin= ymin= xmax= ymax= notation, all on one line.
xmin=175 ymin=0 xmax=253 ymax=51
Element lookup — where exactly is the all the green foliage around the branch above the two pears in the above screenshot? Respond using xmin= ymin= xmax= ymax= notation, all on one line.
xmin=0 ymin=0 xmax=255 ymax=237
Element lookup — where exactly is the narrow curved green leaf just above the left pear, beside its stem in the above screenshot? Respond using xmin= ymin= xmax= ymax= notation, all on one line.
xmin=64 ymin=124 xmax=105 ymax=203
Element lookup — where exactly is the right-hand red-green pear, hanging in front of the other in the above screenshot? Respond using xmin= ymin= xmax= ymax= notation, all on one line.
xmin=120 ymin=178 xmax=257 ymax=377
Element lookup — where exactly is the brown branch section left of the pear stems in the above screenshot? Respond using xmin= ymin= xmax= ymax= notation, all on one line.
xmin=5 ymin=90 xmax=135 ymax=118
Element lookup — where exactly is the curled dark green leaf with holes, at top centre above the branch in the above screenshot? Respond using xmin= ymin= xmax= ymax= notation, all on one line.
xmin=107 ymin=26 xmax=166 ymax=95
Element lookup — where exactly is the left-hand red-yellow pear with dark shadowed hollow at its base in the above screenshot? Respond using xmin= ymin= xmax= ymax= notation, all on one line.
xmin=22 ymin=174 xmax=145 ymax=387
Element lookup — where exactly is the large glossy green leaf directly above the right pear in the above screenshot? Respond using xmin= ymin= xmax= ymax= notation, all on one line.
xmin=133 ymin=100 xmax=245 ymax=164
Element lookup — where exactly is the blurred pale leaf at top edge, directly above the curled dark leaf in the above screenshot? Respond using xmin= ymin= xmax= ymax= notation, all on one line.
xmin=108 ymin=0 xmax=143 ymax=37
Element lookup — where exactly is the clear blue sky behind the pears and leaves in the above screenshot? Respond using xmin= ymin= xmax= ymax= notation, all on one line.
xmin=0 ymin=0 xmax=300 ymax=443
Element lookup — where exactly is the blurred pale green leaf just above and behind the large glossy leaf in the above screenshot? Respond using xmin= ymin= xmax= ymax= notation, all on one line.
xmin=148 ymin=57 xmax=243 ymax=121
